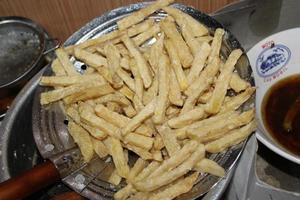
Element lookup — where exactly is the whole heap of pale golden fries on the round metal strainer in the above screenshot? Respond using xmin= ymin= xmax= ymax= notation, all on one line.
xmin=40 ymin=0 xmax=256 ymax=200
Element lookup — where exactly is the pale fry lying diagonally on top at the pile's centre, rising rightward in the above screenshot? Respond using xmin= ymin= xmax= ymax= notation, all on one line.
xmin=122 ymin=99 xmax=156 ymax=136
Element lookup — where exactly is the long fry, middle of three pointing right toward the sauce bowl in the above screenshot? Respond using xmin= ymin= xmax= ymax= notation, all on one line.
xmin=187 ymin=109 xmax=255 ymax=143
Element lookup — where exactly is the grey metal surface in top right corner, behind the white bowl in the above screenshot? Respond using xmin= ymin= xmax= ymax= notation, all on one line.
xmin=213 ymin=0 xmax=300 ymax=51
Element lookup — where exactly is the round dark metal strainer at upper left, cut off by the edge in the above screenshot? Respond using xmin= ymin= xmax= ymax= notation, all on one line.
xmin=0 ymin=17 xmax=46 ymax=88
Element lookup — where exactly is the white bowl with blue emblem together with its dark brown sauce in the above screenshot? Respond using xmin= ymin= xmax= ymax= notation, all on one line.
xmin=247 ymin=28 xmax=300 ymax=164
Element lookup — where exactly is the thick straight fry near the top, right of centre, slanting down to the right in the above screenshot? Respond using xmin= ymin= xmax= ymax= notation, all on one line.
xmin=160 ymin=20 xmax=193 ymax=68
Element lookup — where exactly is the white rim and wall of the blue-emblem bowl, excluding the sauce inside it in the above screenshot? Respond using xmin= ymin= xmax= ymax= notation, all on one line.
xmin=247 ymin=28 xmax=300 ymax=164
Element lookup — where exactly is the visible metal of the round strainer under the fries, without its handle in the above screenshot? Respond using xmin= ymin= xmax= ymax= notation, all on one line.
xmin=32 ymin=3 xmax=253 ymax=199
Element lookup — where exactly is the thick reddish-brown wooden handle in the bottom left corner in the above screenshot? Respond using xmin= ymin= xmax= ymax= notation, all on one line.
xmin=0 ymin=161 xmax=60 ymax=200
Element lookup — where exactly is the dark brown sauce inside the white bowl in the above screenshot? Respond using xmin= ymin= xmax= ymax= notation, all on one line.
xmin=261 ymin=75 xmax=300 ymax=155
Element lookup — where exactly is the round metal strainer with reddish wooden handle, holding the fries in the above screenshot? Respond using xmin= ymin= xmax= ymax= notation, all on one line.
xmin=0 ymin=3 xmax=254 ymax=199
